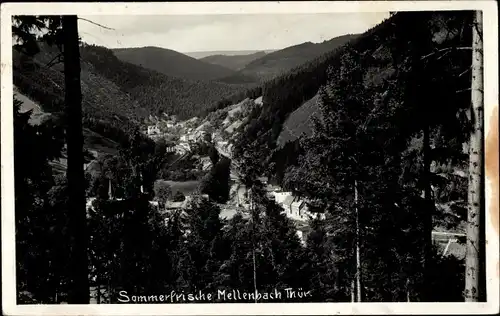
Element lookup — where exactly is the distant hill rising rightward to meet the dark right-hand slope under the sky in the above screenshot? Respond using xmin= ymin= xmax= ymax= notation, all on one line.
xmin=241 ymin=34 xmax=358 ymax=79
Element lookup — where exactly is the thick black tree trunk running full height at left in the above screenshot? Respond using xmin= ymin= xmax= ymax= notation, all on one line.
xmin=62 ymin=15 xmax=90 ymax=304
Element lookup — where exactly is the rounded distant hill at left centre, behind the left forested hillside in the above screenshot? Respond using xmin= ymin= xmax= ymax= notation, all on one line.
xmin=113 ymin=46 xmax=258 ymax=83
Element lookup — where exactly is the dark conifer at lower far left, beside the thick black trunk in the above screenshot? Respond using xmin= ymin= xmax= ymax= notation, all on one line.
xmin=13 ymin=99 xmax=70 ymax=303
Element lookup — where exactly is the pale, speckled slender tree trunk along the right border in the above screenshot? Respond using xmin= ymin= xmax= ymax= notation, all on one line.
xmin=465 ymin=11 xmax=485 ymax=302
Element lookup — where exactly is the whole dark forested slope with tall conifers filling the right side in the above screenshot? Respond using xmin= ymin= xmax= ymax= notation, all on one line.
xmin=235 ymin=12 xmax=472 ymax=301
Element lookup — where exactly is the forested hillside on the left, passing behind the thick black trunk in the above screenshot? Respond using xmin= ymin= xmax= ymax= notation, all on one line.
xmin=13 ymin=44 xmax=252 ymax=139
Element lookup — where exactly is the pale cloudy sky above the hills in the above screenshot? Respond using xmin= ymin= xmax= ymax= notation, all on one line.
xmin=78 ymin=13 xmax=389 ymax=52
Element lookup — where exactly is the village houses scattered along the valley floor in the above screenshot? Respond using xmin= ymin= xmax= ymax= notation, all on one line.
xmin=87 ymin=97 xmax=324 ymax=243
